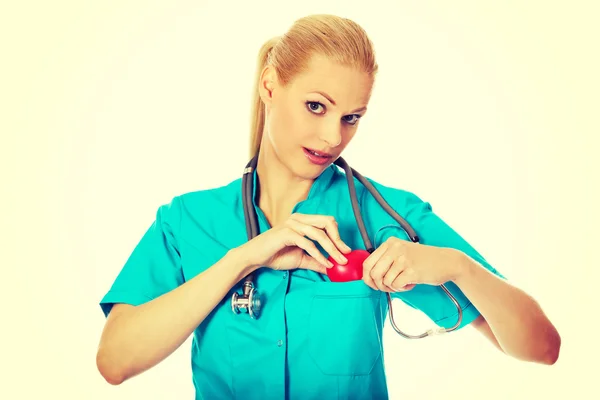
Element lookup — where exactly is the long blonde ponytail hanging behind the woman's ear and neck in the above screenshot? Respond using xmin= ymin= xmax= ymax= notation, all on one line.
xmin=250 ymin=37 xmax=279 ymax=158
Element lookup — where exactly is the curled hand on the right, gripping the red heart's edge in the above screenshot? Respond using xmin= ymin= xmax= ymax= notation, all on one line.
xmin=363 ymin=237 xmax=463 ymax=292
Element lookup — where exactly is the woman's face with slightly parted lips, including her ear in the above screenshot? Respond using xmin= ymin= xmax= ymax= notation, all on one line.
xmin=260 ymin=57 xmax=373 ymax=179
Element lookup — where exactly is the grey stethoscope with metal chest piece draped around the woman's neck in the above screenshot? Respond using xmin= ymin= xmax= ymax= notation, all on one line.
xmin=231 ymin=155 xmax=462 ymax=339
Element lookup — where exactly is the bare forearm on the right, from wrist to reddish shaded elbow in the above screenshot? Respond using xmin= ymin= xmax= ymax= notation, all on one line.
xmin=454 ymin=253 xmax=561 ymax=364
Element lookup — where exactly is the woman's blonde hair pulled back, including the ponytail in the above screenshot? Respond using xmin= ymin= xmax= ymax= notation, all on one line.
xmin=250 ymin=14 xmax=378 ymax=158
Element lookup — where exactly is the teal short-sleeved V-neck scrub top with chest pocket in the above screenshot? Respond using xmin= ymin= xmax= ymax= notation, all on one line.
xmin=100 ymin=164 xmax=501 ymax=400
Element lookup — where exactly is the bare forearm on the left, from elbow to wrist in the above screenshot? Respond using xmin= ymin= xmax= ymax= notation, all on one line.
xmin=97 ymin=252 xmax=255 ymax=384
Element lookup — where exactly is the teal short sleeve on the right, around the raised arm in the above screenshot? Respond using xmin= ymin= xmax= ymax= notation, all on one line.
xmin=375 ymin=192 xmax=504 ymax=329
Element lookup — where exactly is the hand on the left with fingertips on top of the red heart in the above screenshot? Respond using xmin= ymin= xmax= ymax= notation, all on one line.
xmin=239 ymin=213 xmax=351 ymax=274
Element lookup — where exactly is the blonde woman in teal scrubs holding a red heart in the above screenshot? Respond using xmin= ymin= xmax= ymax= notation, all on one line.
xmin=97 ymin=15 xmax=560 ymax=399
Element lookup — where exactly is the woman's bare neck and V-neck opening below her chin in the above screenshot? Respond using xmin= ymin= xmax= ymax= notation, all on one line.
xmin=256 ymin=145 xmax=313 ymax=226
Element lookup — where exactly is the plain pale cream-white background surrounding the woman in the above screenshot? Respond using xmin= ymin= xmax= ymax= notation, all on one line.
xmin=0 ymin=1 xmax=600 ymax=400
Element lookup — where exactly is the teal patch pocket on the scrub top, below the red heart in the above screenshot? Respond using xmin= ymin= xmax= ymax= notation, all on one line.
xmin=307 ymin=281 xmax=383 ymax=376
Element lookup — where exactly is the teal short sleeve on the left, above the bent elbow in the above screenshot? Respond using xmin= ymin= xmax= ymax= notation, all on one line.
xmin=100 ymin=197 xmax=183 ymax=316
